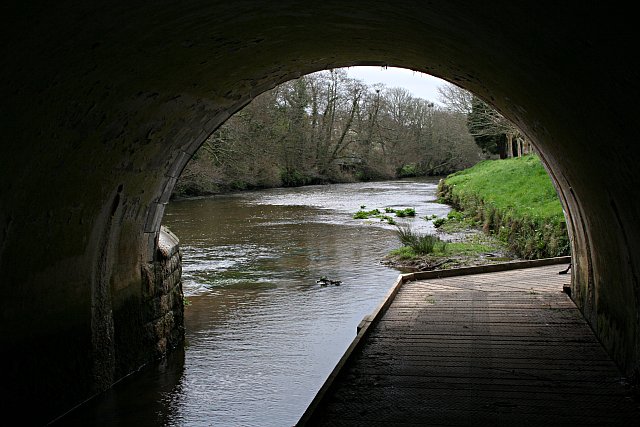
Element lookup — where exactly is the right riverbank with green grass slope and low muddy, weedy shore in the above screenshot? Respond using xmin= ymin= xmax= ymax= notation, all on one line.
xmin=383 ymin=155 xmax=570 ymax=271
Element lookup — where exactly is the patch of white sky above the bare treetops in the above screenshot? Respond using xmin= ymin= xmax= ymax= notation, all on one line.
xmin=345 ymin=67 xmax=447 ymax=104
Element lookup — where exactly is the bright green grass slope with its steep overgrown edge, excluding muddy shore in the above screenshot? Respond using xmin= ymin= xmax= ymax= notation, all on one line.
xmin=438 ymin=155 xmax=569 ymax=259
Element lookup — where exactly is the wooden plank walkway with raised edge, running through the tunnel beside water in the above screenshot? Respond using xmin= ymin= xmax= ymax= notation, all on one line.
xmin=298 ymin=264 xmax=640 ymax=427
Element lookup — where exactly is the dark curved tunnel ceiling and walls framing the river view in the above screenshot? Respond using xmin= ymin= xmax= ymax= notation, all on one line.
xmin=0 ymin=0 xmax=640 ymax=424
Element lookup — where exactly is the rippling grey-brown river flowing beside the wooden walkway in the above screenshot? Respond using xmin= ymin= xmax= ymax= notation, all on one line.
xmin=61 ymin=179 xmax=450 ymax=427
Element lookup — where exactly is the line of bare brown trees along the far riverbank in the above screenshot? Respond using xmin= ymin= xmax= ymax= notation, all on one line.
xmin=174 ymin=70 xmax=484 ymax=196
